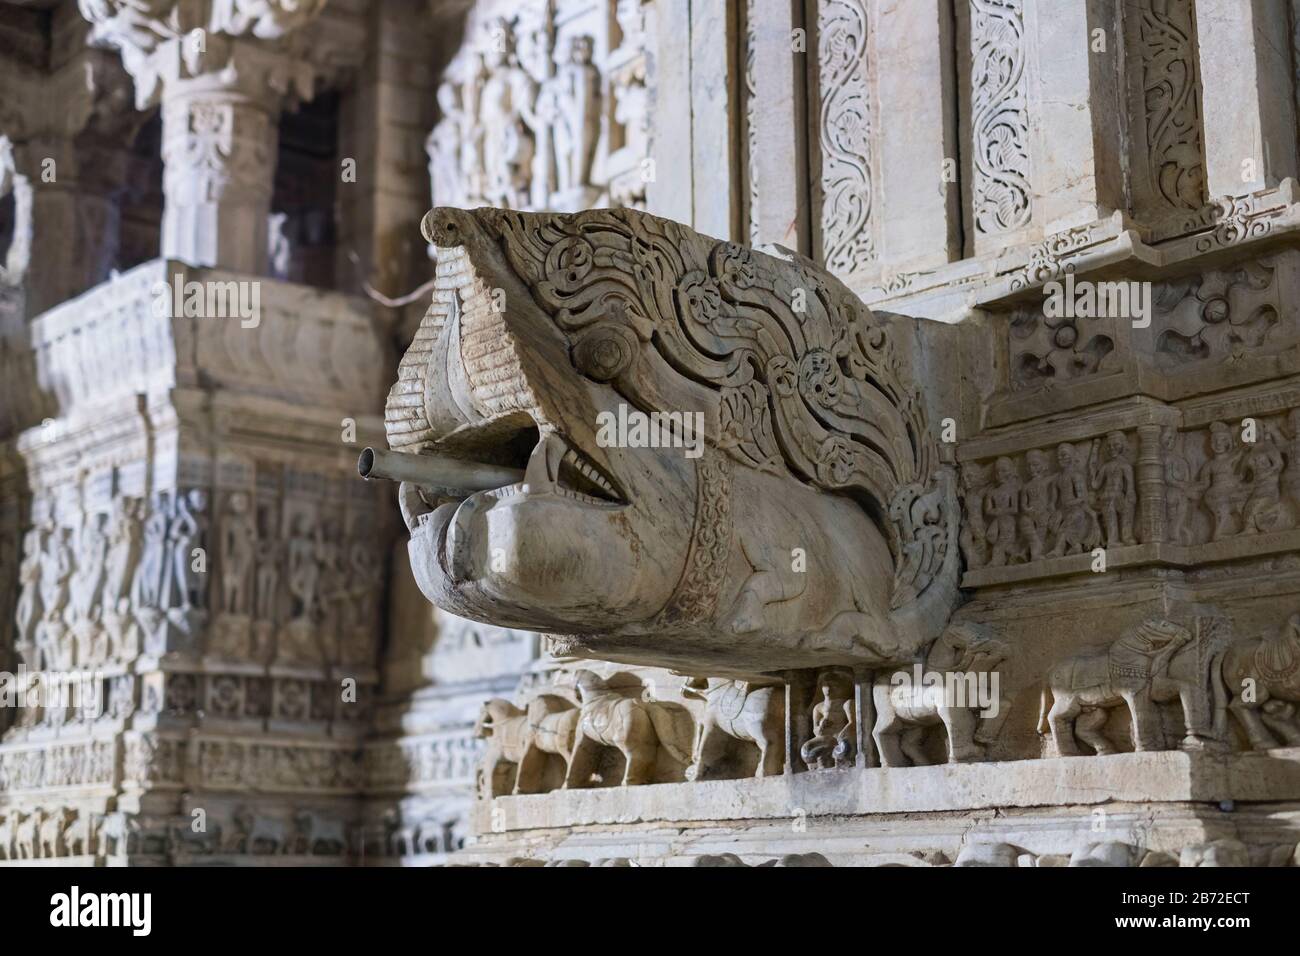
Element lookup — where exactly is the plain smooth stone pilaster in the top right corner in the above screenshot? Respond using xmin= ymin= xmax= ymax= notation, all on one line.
xmin=1196 ymin=0 xmax=1297 ymax=196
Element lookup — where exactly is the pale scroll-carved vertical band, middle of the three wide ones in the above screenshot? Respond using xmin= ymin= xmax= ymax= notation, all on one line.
xmin=971 ymin=0 xmax=1032 ymax=235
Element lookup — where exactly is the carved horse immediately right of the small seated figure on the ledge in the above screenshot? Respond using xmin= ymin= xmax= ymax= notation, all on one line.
xmin=871 ymin=624 xmax=1010 ymax=767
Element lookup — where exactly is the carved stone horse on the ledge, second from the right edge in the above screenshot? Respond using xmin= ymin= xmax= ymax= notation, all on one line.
xmin=1039 ymin=618 xmax=1223 ymax=757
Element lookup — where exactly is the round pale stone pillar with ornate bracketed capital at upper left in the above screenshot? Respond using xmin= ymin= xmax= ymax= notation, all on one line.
xmin=85 ymin=0 xmax=324 ymax=274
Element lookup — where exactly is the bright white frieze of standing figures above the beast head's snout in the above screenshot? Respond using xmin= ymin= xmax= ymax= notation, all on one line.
xmin=425 ymin=0 xmax=637 ymax=209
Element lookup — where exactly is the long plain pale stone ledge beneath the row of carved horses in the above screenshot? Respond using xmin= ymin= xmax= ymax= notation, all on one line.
xmin=476 ymin=748 xmax=1300 ymax=832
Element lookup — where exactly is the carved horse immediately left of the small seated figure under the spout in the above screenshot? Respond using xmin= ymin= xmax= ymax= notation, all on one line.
xmin=683 ymin=679 xmax=785 ymax=780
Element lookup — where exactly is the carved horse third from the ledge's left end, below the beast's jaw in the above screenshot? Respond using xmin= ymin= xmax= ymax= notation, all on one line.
xmin=564 ymin=670 xmax=694 ymax=788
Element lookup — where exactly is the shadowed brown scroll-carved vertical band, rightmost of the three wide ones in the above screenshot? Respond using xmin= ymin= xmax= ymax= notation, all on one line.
xmin=1126 ymin=0 xmax=1205 ymax=211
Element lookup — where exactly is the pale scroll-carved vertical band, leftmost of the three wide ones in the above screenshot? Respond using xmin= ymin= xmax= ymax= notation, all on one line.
xmin=818 ymin=0 xmax=875 ymax=277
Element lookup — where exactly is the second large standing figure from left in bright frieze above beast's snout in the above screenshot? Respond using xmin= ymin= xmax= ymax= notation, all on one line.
xmin=480 ymin=18 xmax=537 ymax=207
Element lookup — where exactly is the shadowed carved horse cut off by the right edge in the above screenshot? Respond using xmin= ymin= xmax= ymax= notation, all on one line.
xmin=1222 ymin=614 xmax=1300 ymax=750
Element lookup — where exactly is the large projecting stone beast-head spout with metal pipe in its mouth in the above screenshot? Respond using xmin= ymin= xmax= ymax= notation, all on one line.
xmin=379 ymin=208 xmax=958 ymax=675
